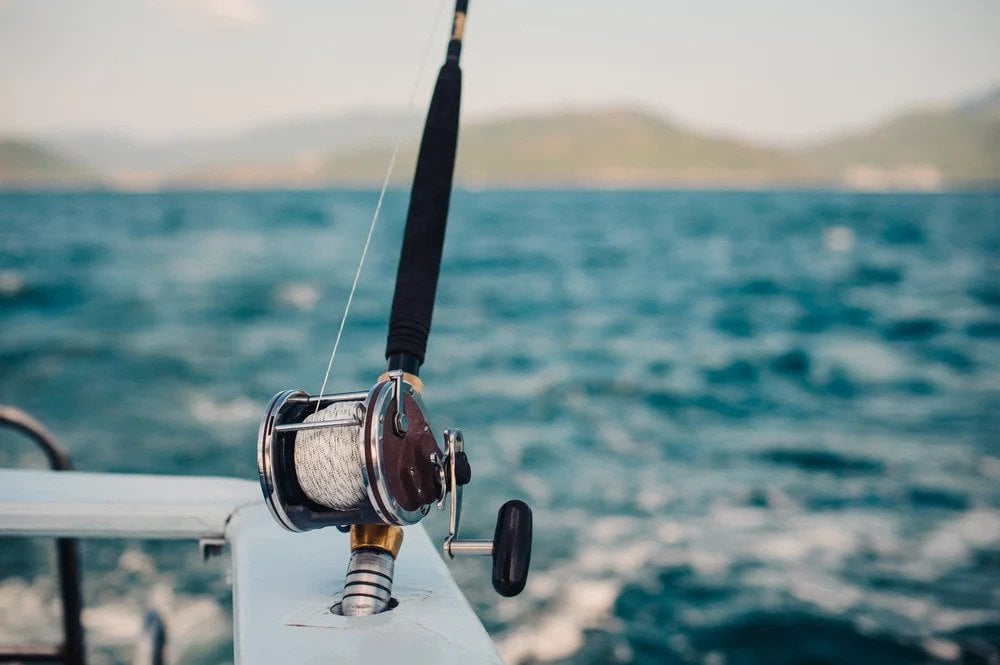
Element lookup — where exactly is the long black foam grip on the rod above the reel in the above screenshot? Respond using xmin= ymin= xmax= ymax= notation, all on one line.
xmin=385 ymin=53 xmax=462 ymax=369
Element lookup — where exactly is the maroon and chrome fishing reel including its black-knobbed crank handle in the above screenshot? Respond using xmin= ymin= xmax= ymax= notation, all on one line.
xmin=257 ymin=370 xmax=531 ymax=611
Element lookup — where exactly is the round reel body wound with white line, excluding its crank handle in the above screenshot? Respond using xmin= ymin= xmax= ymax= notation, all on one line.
xmin=257 ymin=372 xmax=447 ymax=531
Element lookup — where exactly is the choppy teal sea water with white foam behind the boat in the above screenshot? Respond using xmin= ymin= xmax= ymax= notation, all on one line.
xmin=0 ymin=191 xmax=1000 ymax=665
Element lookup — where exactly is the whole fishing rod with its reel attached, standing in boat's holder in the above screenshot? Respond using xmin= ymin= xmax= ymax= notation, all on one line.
xmin=257 ymin=0 xmax=532 ymax=616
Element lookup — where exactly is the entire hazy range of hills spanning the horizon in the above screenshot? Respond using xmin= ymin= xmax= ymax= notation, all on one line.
xmin=0 ymin=89 xmax=1000 ymax=190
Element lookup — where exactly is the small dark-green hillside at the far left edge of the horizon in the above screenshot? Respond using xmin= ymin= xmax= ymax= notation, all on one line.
xmin=0 ymin=139 xmax=99 ymax=189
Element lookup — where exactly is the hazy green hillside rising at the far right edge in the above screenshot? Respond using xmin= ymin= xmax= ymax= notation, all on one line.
xmin=801 ymin=90 xmax=1000 ymax=189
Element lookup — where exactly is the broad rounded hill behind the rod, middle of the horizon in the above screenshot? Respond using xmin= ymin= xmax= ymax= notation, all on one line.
xmin=322 ymin=110 xmax=812 ymax=187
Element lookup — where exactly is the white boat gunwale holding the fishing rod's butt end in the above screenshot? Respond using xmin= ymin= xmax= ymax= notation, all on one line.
xmin=0 ymin=469 xmax=502 ymax=665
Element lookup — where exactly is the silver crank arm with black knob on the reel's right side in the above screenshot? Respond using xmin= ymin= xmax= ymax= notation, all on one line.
xmin=438 ymin=429 xmax=532 ymax=597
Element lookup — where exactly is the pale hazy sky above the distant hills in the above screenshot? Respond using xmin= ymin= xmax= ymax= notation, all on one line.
xmin=0 ymin=0 xmax=1000 ymax=144
